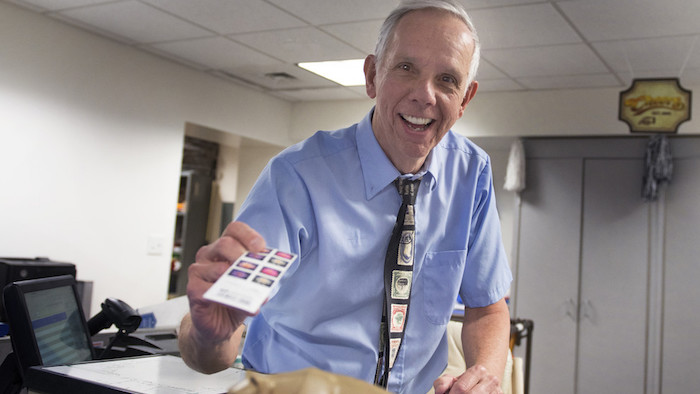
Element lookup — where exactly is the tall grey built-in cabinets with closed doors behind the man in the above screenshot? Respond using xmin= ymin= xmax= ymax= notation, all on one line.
xmin=512 ymin=138 xmax=700 ymax=394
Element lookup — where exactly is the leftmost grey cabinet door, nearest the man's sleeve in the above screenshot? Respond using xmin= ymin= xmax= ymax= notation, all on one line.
xmin=514 ymin=159 xmax=582 ymax=394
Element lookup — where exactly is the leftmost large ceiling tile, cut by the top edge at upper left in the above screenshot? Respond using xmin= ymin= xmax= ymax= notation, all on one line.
xmin=59 ymin=1 xmax=212 ymax=43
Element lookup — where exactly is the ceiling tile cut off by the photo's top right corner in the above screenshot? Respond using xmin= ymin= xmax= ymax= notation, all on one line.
xmin=557 ymin=0 xmax=700 ymax=41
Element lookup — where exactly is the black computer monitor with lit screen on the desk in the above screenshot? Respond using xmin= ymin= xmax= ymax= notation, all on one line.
xmin=3 ymin=275 xmax=95 ymax=374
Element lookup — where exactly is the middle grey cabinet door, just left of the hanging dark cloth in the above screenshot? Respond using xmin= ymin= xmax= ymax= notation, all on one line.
xmin=576 ymin=159 xmax=649 ymax=394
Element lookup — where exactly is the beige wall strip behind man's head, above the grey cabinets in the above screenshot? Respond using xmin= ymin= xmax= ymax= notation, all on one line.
xmin=290 ymin=85 xmax=700 ymax=141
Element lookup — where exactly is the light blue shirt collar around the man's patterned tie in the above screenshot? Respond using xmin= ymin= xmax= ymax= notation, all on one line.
xmin=355 ymin=108 xmax=439 ymax=200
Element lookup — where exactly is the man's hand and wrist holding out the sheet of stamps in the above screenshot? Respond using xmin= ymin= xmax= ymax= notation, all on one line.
xmin=179 ymin=222 xmax=265 ymax=373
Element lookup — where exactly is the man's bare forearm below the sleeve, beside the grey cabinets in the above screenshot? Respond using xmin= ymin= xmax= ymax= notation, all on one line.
xmin=462 ymin=299 xmax=510 ymax=381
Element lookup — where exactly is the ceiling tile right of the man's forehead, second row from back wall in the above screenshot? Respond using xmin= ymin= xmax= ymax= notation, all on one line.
xmin=484 ymin=44 xmax=609 ymax=77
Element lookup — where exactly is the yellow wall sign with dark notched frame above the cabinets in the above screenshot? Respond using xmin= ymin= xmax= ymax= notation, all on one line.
xmin=619 ymin=78 xmax=692 ymax=133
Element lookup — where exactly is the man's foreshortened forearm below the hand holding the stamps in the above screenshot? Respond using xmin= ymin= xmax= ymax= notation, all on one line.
xmin=178 ymin=314 xmax=245 ymax=374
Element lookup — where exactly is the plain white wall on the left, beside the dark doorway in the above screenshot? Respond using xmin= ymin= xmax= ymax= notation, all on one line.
xmin=0 ymin=2 xmax=291 ymax=311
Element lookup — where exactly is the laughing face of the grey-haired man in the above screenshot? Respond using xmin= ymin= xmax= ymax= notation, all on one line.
xmin=365 ymin=9 xmax=477 ymax=173
